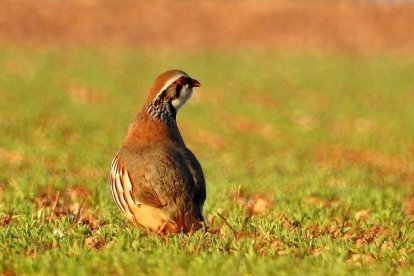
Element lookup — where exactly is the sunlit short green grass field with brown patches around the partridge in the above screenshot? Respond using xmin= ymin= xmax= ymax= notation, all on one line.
xmin=0 ymin=46 xmax=414 ymax=275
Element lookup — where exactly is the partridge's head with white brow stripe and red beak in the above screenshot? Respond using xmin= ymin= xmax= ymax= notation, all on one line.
xmin=147 ymin=70 xmax=200 ymax=113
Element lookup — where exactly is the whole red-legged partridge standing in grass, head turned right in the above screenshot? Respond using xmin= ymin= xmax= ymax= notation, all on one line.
xmin=109 ymin=70 xmax=206 ymax=235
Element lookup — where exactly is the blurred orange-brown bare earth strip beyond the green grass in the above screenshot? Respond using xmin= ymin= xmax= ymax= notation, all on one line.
xmin=0 ymin=0 xmax=414 ymax=53
